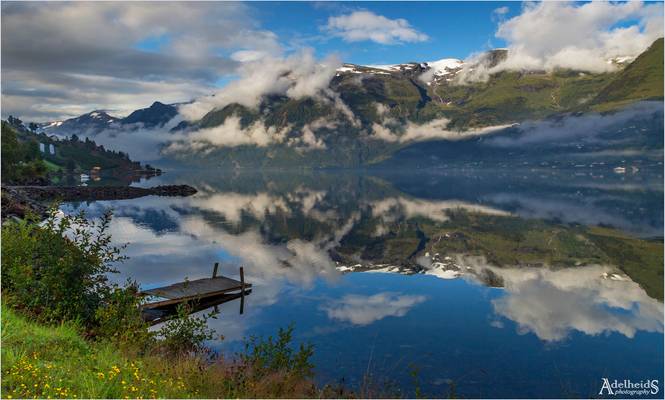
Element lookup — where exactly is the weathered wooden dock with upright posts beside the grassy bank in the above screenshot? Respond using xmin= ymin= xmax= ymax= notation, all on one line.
xmin=139 ymin=263 xmax=252 ymax=310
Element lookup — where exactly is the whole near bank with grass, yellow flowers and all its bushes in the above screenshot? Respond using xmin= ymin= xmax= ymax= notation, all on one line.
xmin=1 ymin=213 xmax=340 ymax=398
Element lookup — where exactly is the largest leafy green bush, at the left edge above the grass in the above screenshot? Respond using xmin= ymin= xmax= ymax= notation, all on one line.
xmin=2 ymin=211 xmax=124 ymax=327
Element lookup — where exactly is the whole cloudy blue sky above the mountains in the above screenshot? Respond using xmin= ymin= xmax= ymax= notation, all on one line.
xmin=1 ymin=1 xmax=663 ymax=122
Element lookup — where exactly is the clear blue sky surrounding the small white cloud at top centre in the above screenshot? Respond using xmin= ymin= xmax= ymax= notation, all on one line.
xmin=251 ymin=2 xmax=521 ymax=64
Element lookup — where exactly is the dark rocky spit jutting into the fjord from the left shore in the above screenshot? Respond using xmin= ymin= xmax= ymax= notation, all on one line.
xmin=2 ymin=185 xmax=197 ymax=220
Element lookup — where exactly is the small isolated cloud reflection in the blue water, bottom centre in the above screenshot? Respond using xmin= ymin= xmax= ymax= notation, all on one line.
xmin=323 ymin=292 xmax=427 ymax=326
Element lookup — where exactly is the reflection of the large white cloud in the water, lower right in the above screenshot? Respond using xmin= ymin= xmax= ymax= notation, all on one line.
xmin=460 ymin=262 xmax=663 ymax=342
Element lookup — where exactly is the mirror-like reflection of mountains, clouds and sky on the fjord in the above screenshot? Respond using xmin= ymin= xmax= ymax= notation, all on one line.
xmin=65 ymin=172 xmax=663 ymax=397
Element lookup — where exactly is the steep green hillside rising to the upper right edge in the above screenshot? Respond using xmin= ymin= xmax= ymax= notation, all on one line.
xmin=592 ymin=38 xmax=663 ymax=111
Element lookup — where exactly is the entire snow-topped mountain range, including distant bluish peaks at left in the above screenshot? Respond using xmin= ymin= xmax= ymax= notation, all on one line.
xmin=40 ymin=38 xmax=663 ymax=167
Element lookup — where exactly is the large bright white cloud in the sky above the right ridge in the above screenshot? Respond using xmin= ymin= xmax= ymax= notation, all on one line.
xmin=456 ymin=1 xmax=663 ymax=84
